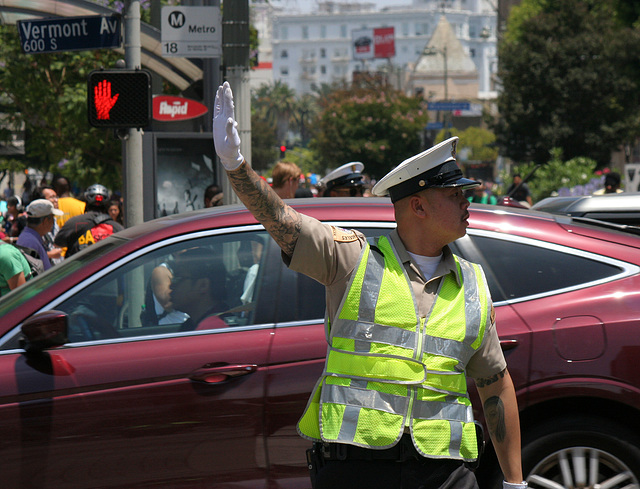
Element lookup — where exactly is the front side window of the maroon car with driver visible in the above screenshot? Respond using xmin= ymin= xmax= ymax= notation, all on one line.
xmin=56 ymin=231 xmax=268 ymax=343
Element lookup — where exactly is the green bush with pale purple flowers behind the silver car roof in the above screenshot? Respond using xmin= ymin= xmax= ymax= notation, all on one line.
xmin=502 ymin=148 xmax=597 ymax=202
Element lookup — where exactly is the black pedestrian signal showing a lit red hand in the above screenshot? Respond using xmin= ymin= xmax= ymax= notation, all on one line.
xmin=87 ymin=70 xmax=152 ymax=128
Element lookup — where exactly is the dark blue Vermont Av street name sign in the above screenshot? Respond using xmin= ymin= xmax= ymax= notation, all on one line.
xmin=16 ymin=14 xmax=122 ymax=54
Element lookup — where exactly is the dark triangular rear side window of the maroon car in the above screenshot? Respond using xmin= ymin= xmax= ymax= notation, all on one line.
xmin=467 ymin=236 xmax=620 ymax=302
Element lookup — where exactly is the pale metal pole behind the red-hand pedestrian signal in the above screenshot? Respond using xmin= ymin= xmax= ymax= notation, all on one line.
xmin=123 ymin=0 xmax=144 ymax=227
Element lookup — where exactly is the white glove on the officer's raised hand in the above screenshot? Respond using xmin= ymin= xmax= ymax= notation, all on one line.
xmin=213 ymin=82 xmax=244 ymax=171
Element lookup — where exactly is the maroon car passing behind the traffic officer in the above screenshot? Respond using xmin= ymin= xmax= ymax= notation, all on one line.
xmin=0 ymin=198 xmax=640 ymax=489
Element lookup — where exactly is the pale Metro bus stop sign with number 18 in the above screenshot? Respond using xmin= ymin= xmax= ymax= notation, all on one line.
xmin=161 ymin=6 xmax=222 ymax=58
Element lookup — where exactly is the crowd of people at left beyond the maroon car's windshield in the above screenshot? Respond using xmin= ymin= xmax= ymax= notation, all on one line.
xmin=0 ymin=175 xmax=124 ymax=295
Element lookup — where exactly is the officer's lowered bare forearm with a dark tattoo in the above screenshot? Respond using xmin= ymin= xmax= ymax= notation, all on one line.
xmin=475 ymin=369 xmax=522 ymax=483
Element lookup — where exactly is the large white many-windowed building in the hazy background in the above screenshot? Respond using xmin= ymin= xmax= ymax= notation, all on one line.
xmin=252 ymin=0 xmax=497 ymax=100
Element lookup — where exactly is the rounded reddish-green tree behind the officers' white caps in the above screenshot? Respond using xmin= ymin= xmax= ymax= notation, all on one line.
xmin=309 ymin=86 xmax=427 ymax=178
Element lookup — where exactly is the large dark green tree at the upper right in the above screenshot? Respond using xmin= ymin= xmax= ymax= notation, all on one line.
xmin=495 ymin=0 xmax=640 ymax=166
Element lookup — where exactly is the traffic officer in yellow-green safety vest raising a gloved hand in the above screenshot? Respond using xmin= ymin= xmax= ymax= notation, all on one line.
xmin=213 ymin=82 xmax=526 ymax=489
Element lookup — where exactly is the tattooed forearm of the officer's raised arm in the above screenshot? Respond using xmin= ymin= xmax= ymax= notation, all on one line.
xmin=227 ymin=163 xmax=301 ymax=256
